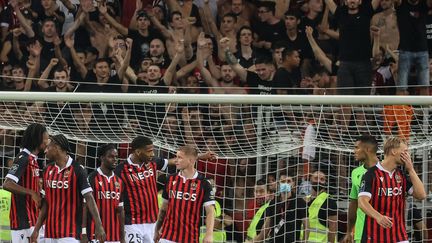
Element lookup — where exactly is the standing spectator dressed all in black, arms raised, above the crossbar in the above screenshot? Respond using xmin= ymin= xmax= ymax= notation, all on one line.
xmin=326 ymin=0 xmax=379 ymax=95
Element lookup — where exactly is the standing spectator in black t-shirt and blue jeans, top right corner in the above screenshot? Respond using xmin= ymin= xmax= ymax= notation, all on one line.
xmin=395 ymin=0 xmax=429 ymax=95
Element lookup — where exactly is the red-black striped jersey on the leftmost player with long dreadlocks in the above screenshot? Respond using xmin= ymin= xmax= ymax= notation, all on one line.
xmin=6 ymin=149 xmax=40 ymax=230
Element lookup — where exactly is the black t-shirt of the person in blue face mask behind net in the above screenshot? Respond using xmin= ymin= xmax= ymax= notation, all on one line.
xmin=266 ymin=197 xmax=307 ymax=243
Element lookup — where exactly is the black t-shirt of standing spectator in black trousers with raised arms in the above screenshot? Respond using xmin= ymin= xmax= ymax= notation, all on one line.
xmin=334 ymin=2 xmax=374 ymax=62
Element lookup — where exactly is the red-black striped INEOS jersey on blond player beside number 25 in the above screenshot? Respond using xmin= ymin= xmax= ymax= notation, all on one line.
xmin=161 ymin=172 xmax=215 ymax=243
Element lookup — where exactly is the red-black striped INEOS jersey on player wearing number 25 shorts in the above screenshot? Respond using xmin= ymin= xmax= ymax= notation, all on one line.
xmin=115 ymin=156 xmax=168 ymax=225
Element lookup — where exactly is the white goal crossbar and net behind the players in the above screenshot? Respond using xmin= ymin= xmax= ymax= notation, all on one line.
xmin=0 ymin=92 xmax=432 ymax=242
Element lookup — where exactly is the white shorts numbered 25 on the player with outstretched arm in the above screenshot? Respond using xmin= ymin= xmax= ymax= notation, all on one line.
xmin=125 ymin=223 xmax=156 ymax=243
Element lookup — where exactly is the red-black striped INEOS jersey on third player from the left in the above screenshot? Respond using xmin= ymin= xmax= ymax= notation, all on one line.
xmin=87 ymin=168 xmax=124 ymax=241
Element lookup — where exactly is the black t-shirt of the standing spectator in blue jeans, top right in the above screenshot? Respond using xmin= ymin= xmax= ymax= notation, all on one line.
xmin=396 ymin=0 xmax=428 ymax=52
